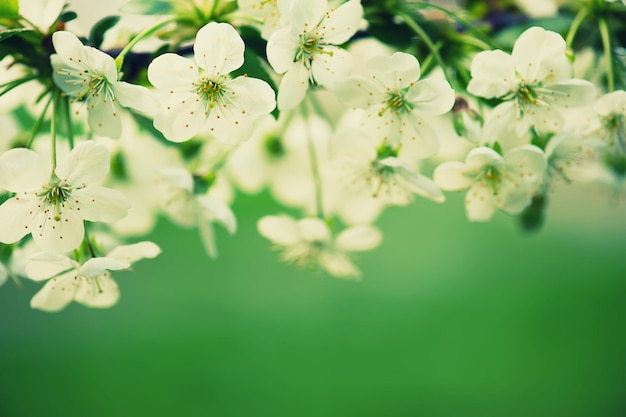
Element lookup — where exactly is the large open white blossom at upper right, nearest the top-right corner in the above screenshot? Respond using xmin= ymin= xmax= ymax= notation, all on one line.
xmin=467 ymin=27 xmax=595 ymax=142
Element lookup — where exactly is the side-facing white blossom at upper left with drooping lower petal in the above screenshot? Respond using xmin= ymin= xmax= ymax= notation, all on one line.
xmin=50 ymin=31 xmax=156 ymax=138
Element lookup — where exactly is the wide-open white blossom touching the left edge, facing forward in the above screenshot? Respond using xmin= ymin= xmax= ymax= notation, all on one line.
xmin=0 ymin=141 xmax=129 ymax=252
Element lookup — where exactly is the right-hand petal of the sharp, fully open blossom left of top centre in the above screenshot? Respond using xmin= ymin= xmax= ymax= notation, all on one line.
xmin=226 ymin=77 xmax=276 ymax=116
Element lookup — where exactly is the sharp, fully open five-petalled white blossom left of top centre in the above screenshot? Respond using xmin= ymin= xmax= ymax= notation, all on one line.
xmin=148 ymin=22 xmax=276 ymax=145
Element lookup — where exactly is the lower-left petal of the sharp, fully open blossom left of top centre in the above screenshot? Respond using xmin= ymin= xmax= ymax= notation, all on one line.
xmin=154 ymin=93 xmax=207 ymax=142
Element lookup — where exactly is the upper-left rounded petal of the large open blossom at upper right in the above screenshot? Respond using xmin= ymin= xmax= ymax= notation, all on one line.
xmin=467 ymin=50 xmax=517 ymax=98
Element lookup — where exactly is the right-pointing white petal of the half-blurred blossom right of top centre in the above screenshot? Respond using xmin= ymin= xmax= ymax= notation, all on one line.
xmin=406 ymin=78 xmax=454 ymax=115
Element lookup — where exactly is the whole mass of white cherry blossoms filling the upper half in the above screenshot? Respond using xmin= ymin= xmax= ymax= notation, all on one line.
xmin=0 ymin=0 xmax=626 ymax=311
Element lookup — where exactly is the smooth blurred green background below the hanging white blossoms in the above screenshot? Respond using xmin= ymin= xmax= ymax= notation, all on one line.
xmin=0 ymin=188 xmax=626 ymax=417
